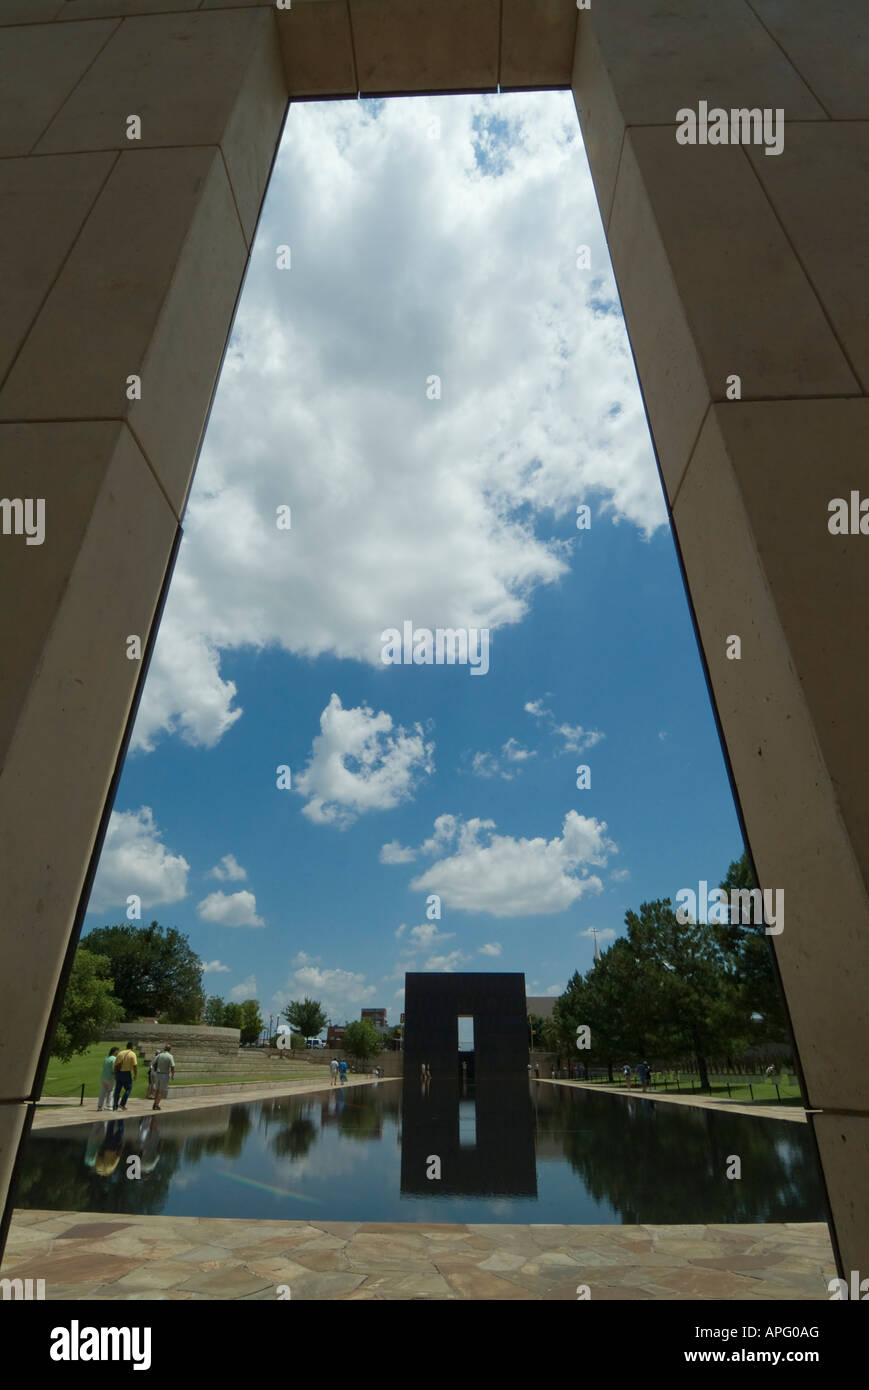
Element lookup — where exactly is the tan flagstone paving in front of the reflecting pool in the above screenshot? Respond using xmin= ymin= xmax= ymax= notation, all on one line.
xmin=0 ymin=1211 xmax=836 ymax=1302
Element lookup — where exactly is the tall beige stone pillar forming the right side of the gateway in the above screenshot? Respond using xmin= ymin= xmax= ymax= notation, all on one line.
xmin=573 ymin=0 xmax=869 ymax=1268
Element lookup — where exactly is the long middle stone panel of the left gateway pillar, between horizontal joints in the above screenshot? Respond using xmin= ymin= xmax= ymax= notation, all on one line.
xmin=0 ymin=421 xmax=178 ymax=1099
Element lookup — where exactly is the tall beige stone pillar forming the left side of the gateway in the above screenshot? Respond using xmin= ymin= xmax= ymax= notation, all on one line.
xmin=0 ymin=0 xmax=286 ymax=1239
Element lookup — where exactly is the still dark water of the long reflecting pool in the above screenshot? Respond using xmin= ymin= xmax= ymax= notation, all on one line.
xmin=17 ymin=1080 xmax=825 ymax=1225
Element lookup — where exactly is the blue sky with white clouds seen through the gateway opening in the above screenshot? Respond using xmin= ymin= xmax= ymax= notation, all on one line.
xmin=85 ymin=93 xmax=741 ymax=1020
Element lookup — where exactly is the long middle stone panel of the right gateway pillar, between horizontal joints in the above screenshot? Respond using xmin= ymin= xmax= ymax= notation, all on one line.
xmin=674 ymin=400 xmax=869 ymax=1109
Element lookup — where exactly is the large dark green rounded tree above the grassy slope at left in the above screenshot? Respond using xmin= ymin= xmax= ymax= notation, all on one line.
xmin=82 ymin=922 xmax=204 ymax=1023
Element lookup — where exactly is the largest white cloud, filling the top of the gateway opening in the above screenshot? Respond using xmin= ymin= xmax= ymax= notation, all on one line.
xmin=127 ymin=92 xmax=656 ymax=751
